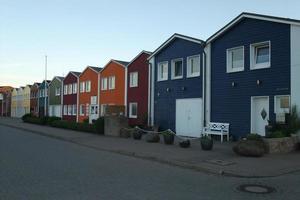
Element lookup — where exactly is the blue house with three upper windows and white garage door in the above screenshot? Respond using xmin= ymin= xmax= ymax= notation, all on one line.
xmin=148 ymin=34 xmax=205 ymax=137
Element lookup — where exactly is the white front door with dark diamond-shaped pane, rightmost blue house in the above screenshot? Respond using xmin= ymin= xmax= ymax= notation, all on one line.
xmin=251 ymin=97 xmax=269 ymax=136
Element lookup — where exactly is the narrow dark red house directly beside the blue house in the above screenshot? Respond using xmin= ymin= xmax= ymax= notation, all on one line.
xmin=127 ymin=51 xmax=151 ymax=126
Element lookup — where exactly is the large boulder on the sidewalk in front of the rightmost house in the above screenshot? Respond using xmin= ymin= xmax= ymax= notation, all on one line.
xmin=233 ymin=140 xmax=265 ymax=157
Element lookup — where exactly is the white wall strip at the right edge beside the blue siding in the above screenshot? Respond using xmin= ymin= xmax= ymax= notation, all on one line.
xmin=291 ymin=25 xmax=300 ymax=110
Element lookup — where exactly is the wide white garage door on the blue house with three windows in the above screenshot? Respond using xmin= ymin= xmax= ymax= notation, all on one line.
xmin=176 ymin=98 xmax=203 ymax=137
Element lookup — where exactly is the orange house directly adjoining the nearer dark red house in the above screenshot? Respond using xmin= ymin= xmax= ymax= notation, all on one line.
xmin=99 ymin=60 xmax=129 ymax=116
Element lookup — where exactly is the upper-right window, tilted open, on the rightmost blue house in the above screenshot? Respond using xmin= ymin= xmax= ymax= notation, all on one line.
xmin=250 ymin=41 xmax=271 ymax=69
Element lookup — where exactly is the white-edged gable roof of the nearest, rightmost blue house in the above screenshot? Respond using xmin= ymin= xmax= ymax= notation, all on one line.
xmin=206 ymin=12 xmax=300 ymax=43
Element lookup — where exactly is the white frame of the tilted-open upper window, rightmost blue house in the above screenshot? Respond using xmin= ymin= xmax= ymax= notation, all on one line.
xmin=250 ymin=41 xmax=272 ymax=70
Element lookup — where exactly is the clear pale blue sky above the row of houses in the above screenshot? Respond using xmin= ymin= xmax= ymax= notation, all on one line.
xmin=0 ymin=0 xmax=300 ymax=87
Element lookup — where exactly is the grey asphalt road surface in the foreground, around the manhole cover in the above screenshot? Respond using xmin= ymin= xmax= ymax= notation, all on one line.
xmin=0 ymin=126 xmax=300 ymax=200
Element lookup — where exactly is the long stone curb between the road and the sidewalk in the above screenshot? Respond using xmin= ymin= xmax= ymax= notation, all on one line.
xmin=0 ymin=122 xmax=300 ymax=178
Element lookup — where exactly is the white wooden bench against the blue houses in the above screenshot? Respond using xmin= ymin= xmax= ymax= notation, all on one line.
xmin=203 ymin=122 xmax=229 ymax=142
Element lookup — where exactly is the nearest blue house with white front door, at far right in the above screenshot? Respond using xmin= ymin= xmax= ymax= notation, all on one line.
xmin=206 ymin=13 xmax=300 ymax=138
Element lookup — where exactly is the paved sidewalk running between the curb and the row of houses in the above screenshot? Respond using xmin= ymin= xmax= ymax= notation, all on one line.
xmin=0 ymin=117 xmax=300 ymax=177
